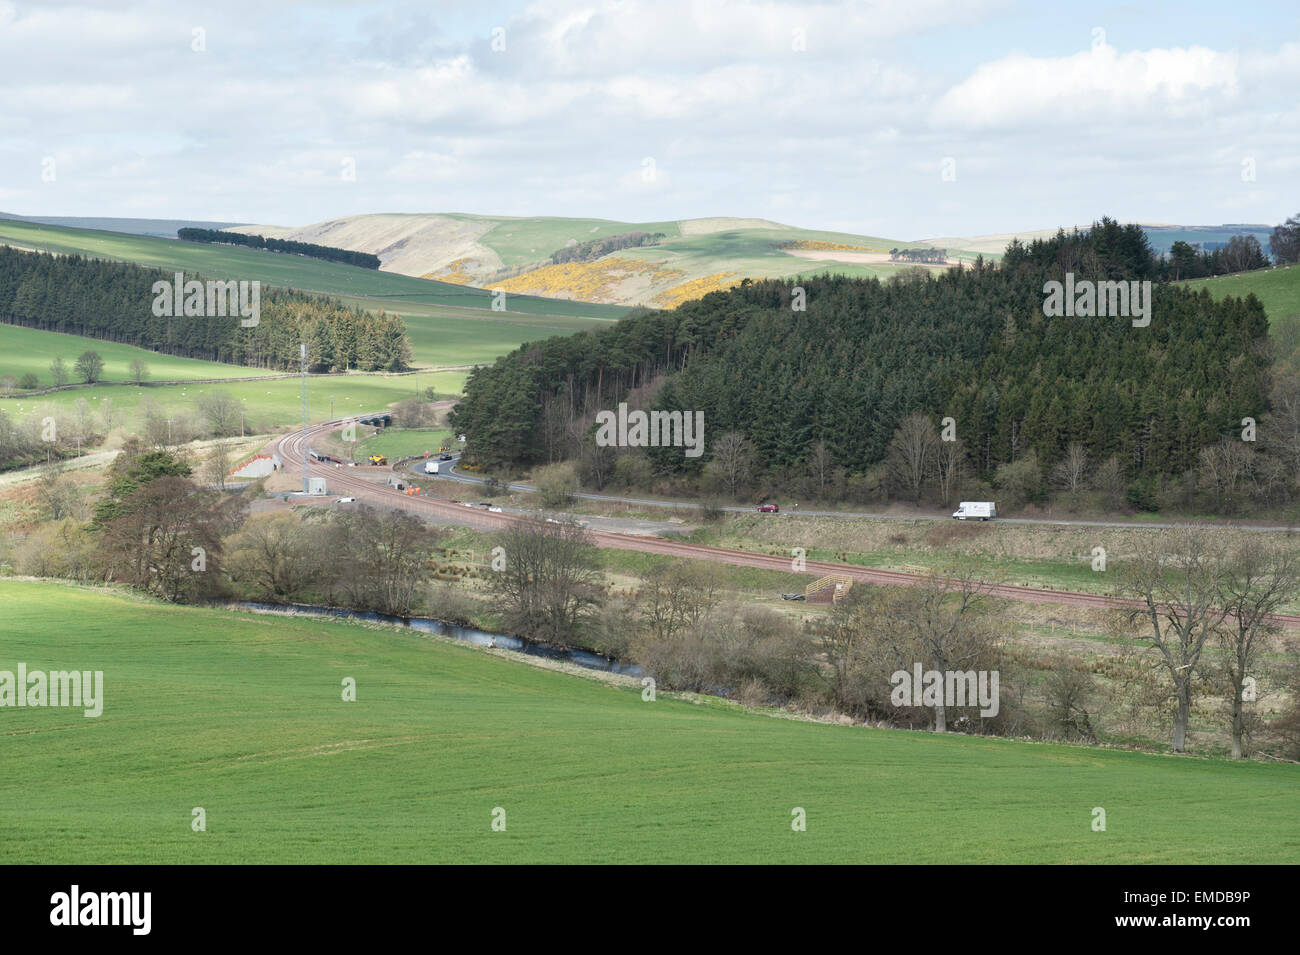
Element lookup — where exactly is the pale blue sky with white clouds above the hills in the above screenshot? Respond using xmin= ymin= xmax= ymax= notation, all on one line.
xmin=0 ymin=0 xmax=1300 ymax=240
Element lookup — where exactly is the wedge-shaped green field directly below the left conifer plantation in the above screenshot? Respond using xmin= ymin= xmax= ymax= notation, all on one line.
xmin=0 ymin=325 xmax=267 ymax=387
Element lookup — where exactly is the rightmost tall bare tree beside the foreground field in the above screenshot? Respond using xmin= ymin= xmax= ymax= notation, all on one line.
xmin=1217 ymin=534 xmax=1300 ymax=758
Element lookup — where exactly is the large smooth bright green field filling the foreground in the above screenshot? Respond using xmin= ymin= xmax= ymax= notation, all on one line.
xmin=0 ymin=581 xmax=1300 ymax=864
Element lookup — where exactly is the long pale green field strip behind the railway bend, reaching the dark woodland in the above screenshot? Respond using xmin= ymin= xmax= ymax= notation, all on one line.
xmin=0 ymin=372 xmax=465 ymax=429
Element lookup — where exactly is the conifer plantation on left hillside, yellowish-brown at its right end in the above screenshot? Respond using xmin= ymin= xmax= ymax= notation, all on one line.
xmin=0 ymin=247 xmax=411 ymax=372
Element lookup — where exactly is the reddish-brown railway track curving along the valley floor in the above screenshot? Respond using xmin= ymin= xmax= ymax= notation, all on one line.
xmin=268 ymin=421 xmax=1300 ymax=630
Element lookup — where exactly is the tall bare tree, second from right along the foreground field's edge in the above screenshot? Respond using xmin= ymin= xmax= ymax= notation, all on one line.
xmin=1119 ymin=528 xmax=1227 ymax=752
